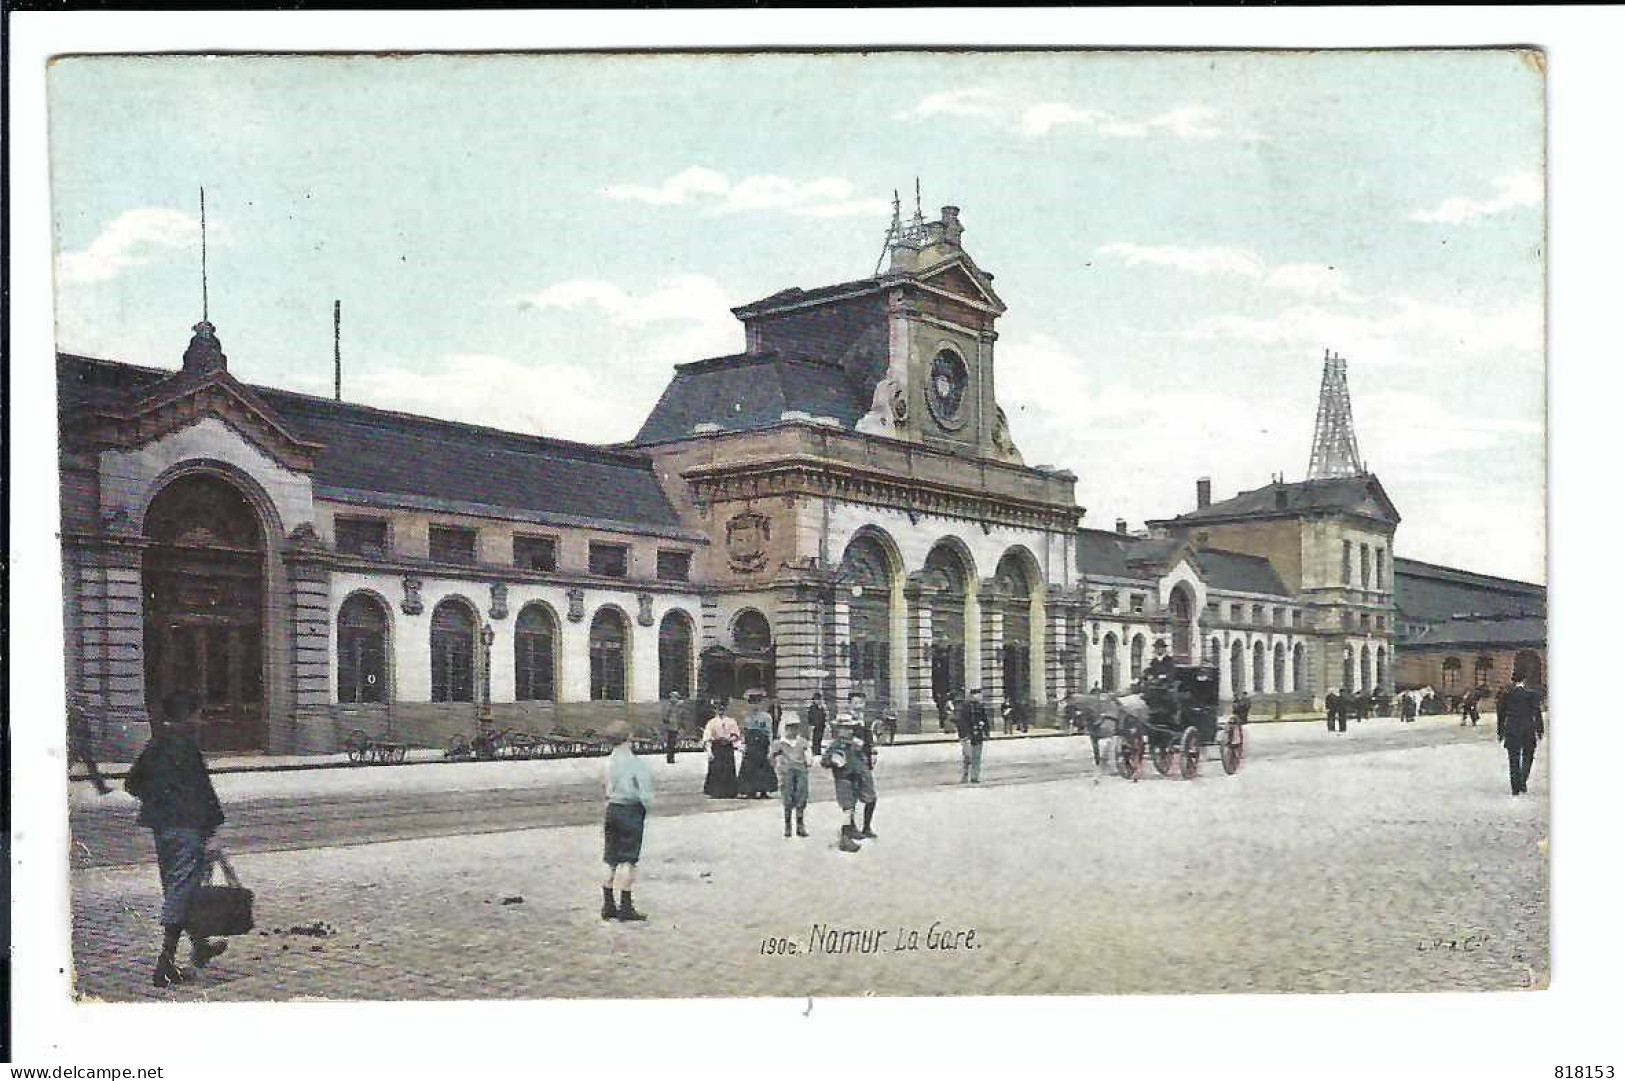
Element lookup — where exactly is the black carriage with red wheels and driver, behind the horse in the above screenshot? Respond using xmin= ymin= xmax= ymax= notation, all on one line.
xmin=1116 ymin=665 xmax=1246 ymax=780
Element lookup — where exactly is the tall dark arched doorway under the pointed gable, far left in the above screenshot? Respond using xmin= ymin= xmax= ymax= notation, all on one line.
xmin=141 ymin=473 xmax=268 ymax=751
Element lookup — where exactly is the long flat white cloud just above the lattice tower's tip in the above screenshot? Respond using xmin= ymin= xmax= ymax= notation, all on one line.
xmin=1185 ymin=296 xmax=1544 ymax=364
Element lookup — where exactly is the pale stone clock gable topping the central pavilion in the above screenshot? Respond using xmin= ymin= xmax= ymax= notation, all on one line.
xmin=856 ymin=206 xmax=1021 ymax=463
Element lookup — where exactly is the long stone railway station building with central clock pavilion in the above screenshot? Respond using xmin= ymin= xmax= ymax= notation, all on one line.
xmin=59 ymin=206 xmax=1540 ymax=758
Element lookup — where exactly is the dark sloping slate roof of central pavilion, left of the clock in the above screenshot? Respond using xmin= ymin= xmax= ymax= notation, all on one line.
xmin=632 ymin=351 xmax=868 ymax=445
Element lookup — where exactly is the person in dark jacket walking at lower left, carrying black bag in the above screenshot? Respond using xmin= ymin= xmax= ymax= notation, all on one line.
xmin=124 ymin=691 xmax=226 ymax=987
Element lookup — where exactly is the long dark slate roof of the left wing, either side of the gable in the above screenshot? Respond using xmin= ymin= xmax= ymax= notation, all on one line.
xmin=57 ymin=354 xmax=681 ymax=532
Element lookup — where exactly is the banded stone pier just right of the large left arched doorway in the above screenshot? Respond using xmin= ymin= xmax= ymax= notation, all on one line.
xmin=282 ymin=527 xmax=338 ymax=754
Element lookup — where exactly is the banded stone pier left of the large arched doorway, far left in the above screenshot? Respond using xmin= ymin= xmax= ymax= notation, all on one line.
xmin=63 ymin=535 xmax=151 ymax=762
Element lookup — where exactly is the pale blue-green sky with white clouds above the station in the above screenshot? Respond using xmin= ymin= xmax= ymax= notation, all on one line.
xmin=49 ymin=50 xmax=1545 ymax=582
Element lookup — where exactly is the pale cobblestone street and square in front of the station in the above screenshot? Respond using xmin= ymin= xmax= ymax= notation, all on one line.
xmin=72 ymin=718 xmax=1549 ymax=1000
